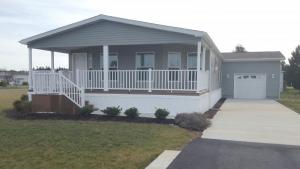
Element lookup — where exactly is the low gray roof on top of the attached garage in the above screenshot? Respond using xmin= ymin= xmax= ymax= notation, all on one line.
xmin=222 ymin=51 xmax=285 ymax=62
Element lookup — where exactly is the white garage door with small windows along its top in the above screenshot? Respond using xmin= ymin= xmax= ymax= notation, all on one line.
xmin=234 ymin=73 xmax=266 ymax=99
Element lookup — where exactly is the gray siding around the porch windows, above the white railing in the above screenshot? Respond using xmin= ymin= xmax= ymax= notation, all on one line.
xmin=72 ymin=44 xmax=197 ymax=70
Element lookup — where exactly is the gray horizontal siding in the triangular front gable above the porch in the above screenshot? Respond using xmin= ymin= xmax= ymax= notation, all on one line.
xmin=29 ymin=21 xmax=200 ymax=49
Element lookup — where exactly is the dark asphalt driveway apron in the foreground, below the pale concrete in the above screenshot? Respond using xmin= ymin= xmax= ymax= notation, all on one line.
xmin=168 ymin=138 xmax=300 ymax=169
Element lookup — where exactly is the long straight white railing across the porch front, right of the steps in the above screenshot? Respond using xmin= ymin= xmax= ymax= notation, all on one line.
xmin=76 ymin=69 xmax=208 ymax=92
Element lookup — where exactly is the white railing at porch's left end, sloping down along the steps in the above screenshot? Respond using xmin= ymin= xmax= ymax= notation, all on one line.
xmin=33 ymin=72 xmax=85 ymax=107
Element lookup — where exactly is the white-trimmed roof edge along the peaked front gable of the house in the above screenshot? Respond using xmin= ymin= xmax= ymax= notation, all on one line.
xmin=20 ymin=15 xmax=207 ymax=44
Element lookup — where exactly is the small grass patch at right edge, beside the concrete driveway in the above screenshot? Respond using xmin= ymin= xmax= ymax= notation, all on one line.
xmin=279 ymin=88 xmax=300 ymax=114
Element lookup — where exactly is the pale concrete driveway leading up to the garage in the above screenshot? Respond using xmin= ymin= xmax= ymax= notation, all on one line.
xmin=202 ymin=99 xmax=300 ymax=145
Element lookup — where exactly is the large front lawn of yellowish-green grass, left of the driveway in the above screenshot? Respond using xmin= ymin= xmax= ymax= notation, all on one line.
xmin=0 ymin=89 xmax=197 ymax=169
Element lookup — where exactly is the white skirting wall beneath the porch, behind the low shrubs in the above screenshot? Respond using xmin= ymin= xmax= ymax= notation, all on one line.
xmin=85 ymin=90 xmax=221 ymax=117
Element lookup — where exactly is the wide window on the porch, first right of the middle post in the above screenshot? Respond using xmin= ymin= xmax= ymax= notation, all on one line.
xmin=135 ymin=52 xmax=155 ymax=70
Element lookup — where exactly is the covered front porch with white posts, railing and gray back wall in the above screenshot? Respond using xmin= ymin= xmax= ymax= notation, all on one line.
xmin=29 ymin=41 xmax=211 ymax=95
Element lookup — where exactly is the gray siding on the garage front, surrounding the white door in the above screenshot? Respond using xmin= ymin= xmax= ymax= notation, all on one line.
xmin=222 ymin=61 xmax=281 ymax=98
